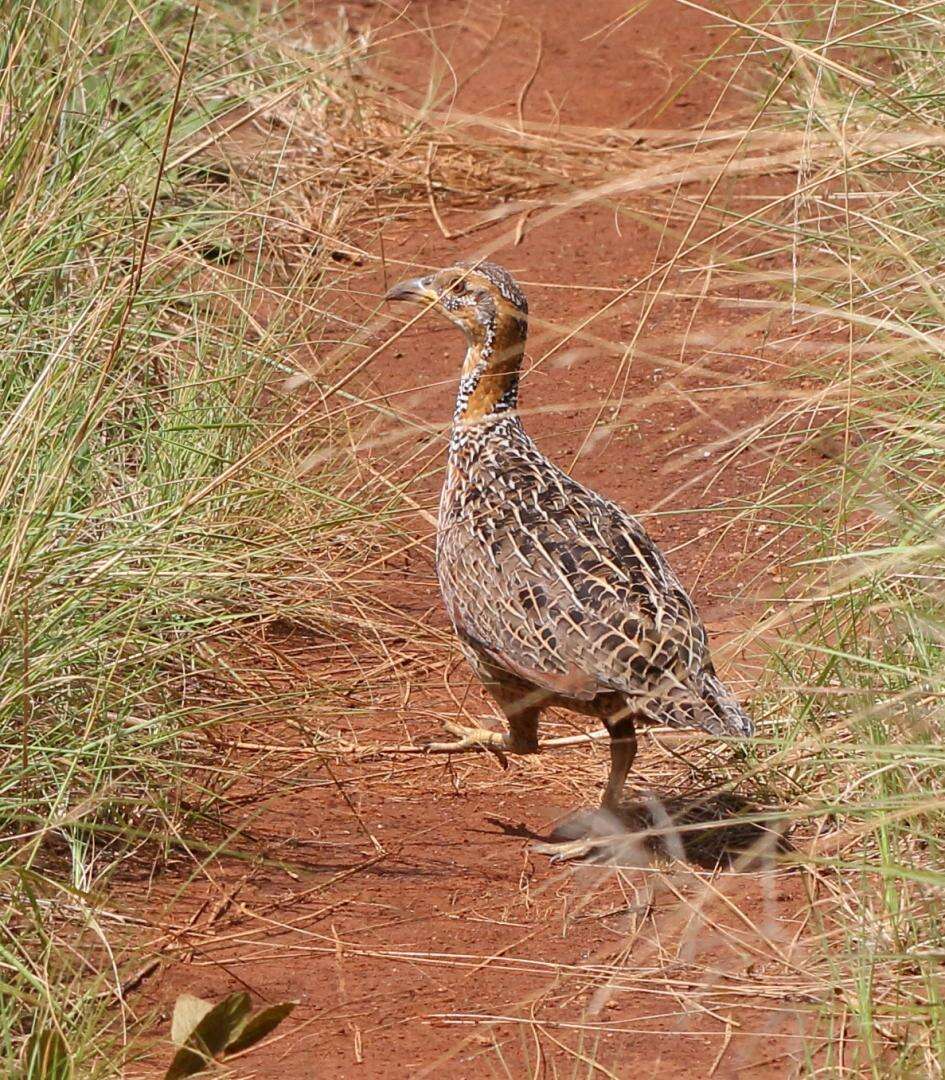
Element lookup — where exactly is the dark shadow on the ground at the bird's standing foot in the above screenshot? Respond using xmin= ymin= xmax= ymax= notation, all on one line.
xmin=487 ymin=791 xmax=793 ymax=870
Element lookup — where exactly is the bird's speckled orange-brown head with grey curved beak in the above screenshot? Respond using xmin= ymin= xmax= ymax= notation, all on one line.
xmin=386 ymin=262 xmax=528 ymax=348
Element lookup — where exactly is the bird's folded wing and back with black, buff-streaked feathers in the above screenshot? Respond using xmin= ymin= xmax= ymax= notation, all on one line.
xmin=437 ymin=462 xmax=751 ymax=734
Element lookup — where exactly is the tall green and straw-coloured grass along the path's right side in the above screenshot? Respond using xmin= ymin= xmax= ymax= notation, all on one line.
xmin=730 ymin=0 xmax=945 ymax=1077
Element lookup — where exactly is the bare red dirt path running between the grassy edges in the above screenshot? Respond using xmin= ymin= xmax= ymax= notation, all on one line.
xmin=138 ymin=0 xmax=804 ymax=1078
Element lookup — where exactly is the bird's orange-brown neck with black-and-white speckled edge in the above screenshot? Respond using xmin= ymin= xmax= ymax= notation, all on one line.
xmin=453 ymin=319 xmax=526 ymax=424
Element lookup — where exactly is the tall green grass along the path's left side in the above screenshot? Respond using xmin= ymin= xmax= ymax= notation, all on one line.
xmin=0 ymin=0 xmax=395 ymax=1077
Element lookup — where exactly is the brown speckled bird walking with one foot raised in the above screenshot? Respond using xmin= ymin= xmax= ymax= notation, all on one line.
xmin=386 ymin=260 xmax=754 ymax=825
